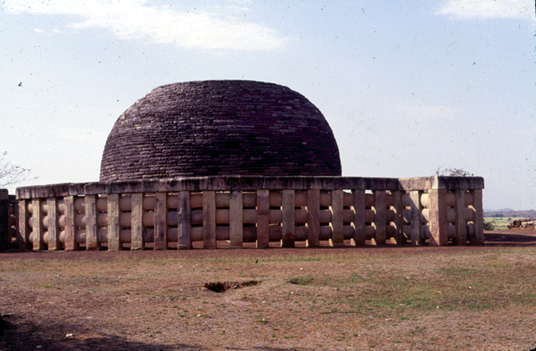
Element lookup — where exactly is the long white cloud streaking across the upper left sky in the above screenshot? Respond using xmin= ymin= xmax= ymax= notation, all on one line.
xmin=3 ymin=0 xmax=288 ymax=51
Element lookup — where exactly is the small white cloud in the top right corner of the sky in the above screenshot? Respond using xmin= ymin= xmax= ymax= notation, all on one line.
xmin=435 ymin=0 xmax=534 ymax=19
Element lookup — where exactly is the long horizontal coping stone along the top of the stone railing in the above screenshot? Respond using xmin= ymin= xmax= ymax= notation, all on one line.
xmin=14 ymin=176 xmax=484 ymax=200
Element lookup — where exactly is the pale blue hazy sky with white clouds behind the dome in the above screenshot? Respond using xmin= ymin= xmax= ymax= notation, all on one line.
xmin=0 ymin=0 xmax=536 ymax=210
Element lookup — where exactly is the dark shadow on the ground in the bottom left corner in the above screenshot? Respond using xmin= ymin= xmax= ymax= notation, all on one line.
xmin=0 ymin=317 xmax=207 ymax=351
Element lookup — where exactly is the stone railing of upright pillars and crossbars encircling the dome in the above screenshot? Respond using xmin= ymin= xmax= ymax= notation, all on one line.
xmin=8 ymin=176 xmax=484 ymax=250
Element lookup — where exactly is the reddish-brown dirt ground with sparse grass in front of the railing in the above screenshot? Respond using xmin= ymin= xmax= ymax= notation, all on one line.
xmin=0 ymin=230 xmax=536 ymax=351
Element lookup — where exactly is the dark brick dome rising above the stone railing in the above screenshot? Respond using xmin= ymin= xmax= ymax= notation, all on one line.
xmin=100 ymin=80 xmax=341 ymax=181
